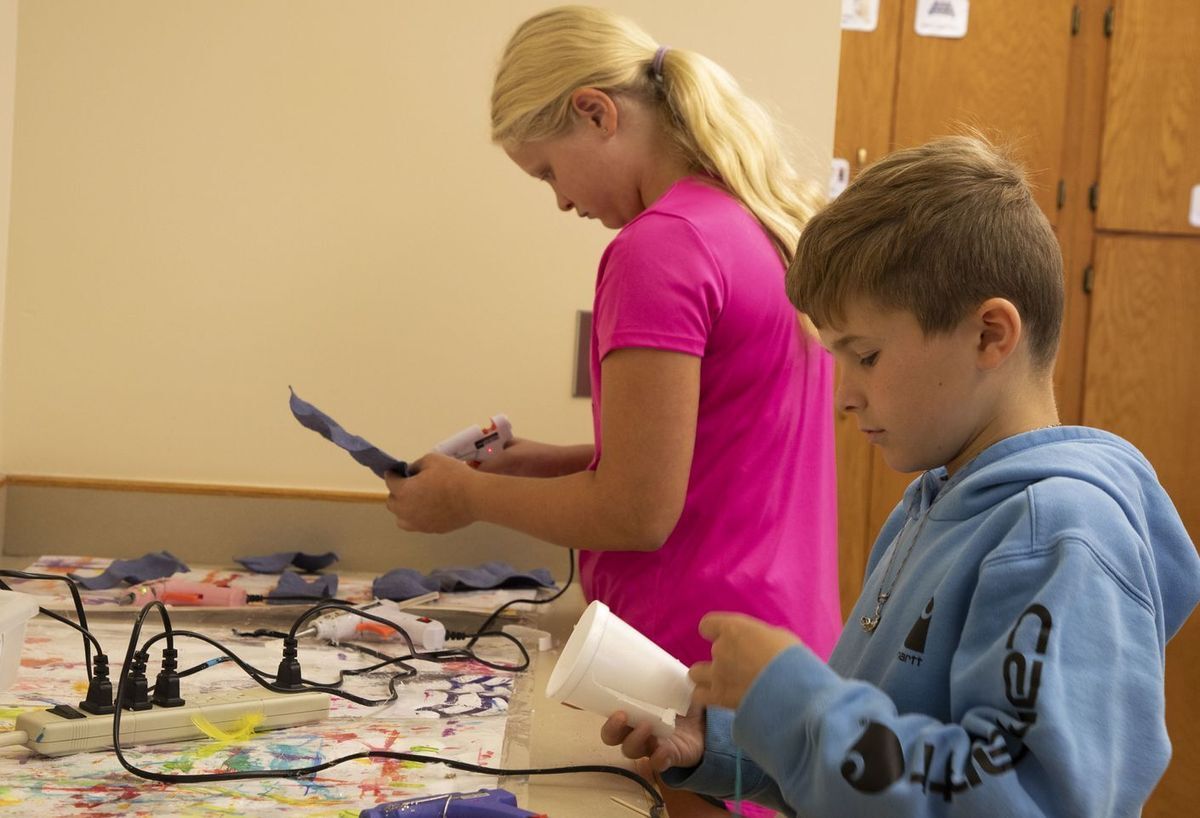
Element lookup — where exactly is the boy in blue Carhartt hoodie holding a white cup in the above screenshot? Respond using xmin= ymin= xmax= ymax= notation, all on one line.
xmin=602 ymin=137 xmax=1200 ymax=818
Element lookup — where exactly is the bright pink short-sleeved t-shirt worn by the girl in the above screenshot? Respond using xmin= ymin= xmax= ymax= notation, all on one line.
xmin=580 ymin=179 xmax=841 ymax=664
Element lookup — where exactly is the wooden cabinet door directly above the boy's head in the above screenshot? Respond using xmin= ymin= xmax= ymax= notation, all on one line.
xmin=895 ymin=0 xmax=1075 ymax=223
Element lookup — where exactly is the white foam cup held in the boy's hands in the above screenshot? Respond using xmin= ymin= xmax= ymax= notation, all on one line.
xmin=546 ymin=600 xmax=695 ymax=738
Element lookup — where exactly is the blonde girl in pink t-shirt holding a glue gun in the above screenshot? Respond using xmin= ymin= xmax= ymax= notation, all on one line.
xmin=389 ymin=6 xmax=841 ymax=676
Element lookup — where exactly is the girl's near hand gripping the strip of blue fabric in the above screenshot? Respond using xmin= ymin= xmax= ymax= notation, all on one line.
xmin=384 ymin=453 xmax=476 ymax=534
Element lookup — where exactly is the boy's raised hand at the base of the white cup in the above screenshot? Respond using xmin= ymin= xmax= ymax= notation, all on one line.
xmin=688 ymin=613 xmax=800 ymax=710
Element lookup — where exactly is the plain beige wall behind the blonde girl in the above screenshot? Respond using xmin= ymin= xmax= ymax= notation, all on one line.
xmin=0 ymin=0 xmax=839 ymax=489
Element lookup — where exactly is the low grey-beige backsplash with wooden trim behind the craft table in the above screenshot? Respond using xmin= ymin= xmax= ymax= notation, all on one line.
xmin=0 ymin=475 xmax=566 ymax=577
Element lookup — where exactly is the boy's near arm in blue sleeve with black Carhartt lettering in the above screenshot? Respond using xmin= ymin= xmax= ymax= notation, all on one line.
xmin=729 ymin=529 xmax=1170 ymax=818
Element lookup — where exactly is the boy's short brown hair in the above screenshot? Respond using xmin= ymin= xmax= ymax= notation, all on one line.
xmin=787 ymin=136 xmax=1063 ymax=368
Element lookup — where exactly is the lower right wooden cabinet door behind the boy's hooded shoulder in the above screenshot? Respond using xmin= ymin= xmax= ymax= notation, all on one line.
xmin=1084 ymin=235 xmax=1200 ymax=818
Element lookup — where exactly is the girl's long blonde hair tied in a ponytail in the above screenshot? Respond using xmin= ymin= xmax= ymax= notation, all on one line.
xmin=492 ymin=6 xmax=820 ymax=263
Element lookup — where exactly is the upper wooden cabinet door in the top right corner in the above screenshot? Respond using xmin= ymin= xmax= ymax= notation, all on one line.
xmin=1097 ymin=0 xmax=1200 ymax=234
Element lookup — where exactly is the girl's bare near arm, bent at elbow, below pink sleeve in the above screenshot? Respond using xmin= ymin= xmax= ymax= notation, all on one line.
xmin=388 ymin=348 xmax=700 ymax=551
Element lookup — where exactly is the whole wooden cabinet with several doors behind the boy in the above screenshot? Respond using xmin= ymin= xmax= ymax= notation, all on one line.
xmin=834 ymin=0 xmax=1200 ymax=818
